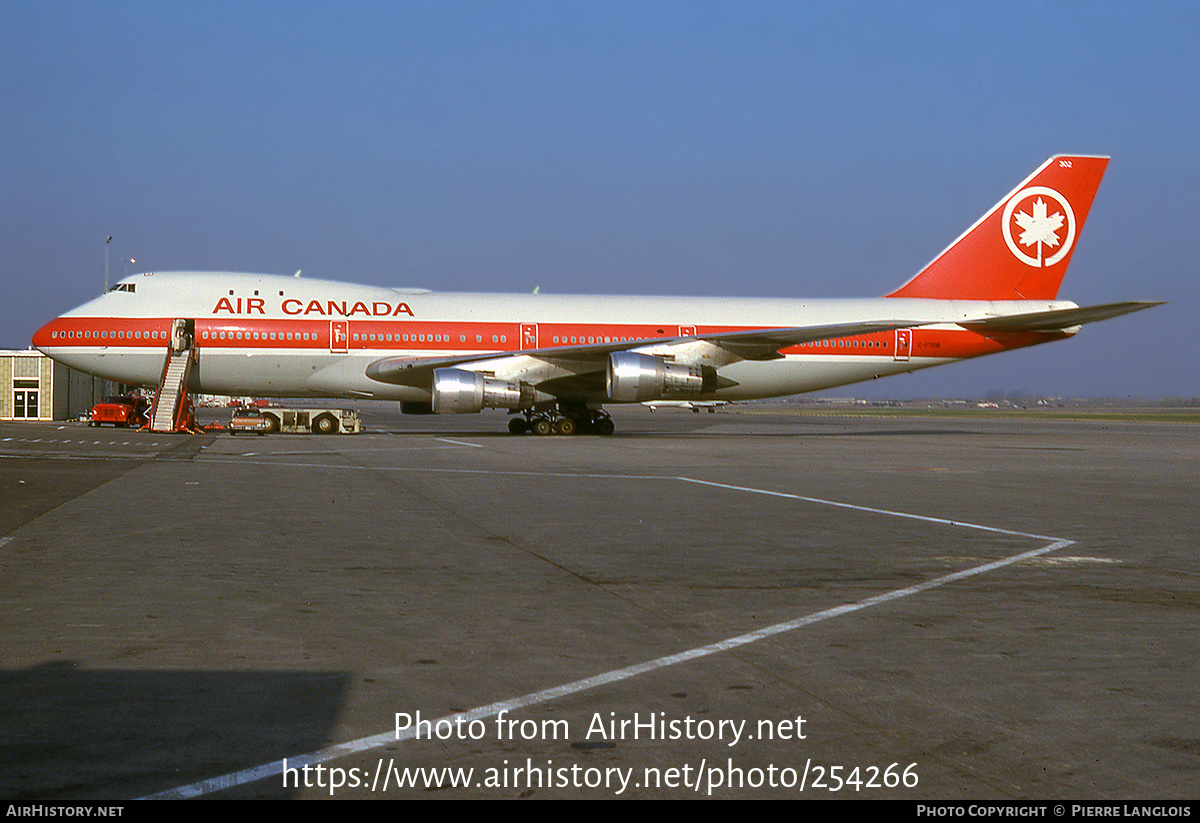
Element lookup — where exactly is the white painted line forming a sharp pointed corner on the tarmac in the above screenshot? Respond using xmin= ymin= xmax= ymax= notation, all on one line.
xmin=142 ymin=471 xmax=1074 ymax=800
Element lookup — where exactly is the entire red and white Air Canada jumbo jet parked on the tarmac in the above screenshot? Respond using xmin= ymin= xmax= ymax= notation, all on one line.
xmin=34 ymin=156 xmax=1157 ymax=434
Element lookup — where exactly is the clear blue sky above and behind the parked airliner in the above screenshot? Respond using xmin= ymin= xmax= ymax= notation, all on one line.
xmin=0 ymin=0 xmax=1200 ymax=397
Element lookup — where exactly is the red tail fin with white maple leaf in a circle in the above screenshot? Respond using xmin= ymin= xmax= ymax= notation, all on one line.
xmin=887 ymin=155 xmax=1109 ymax=300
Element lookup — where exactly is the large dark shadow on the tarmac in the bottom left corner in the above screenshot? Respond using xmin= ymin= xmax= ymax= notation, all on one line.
xmin=0 ymin=661 xmax=350 ymax=800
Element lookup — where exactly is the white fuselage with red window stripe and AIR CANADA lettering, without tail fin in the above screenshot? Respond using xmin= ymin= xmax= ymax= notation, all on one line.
xmin=34 ymin=272 xmax=1074 ymax=401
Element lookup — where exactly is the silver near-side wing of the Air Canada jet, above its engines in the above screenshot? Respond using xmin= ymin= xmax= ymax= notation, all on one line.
xmin=366 ymin=319 xmax=928 ymax=388
